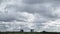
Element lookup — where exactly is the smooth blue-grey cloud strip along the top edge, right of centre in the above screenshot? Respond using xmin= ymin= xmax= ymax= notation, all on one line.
xmin=23 ymin=0 xmax=60 ymax=4
